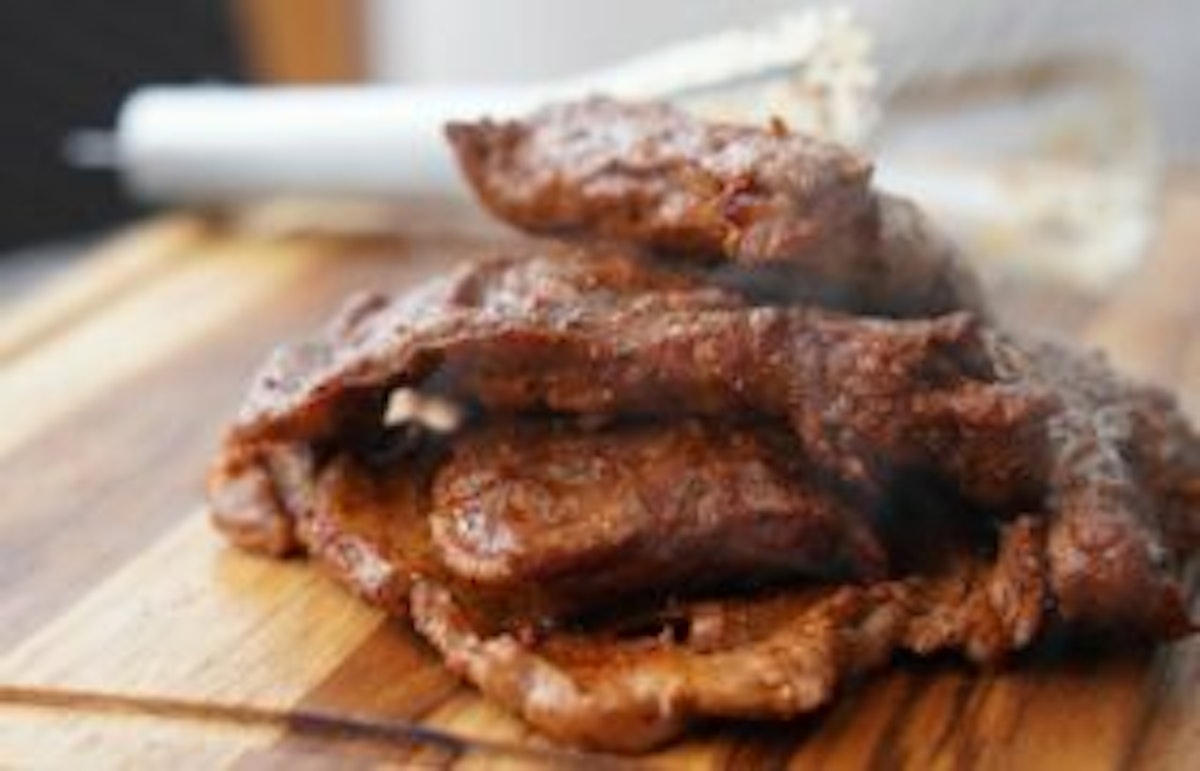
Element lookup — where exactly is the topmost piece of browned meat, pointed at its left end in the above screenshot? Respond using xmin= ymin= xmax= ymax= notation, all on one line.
xmin=446 ymin=98 xmax=984 ymax=316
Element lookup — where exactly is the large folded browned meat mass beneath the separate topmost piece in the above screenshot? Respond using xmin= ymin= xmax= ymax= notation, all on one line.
xmin=212 ymin=250 xmax=1200 ymax=749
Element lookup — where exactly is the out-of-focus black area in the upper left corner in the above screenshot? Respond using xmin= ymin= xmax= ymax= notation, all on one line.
xmin=0 ymin=0 xmax=242 ymax=253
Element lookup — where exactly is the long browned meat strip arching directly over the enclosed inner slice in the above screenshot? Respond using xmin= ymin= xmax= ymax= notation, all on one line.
xmin=234 ymin=254 xmax=1046 ymax=502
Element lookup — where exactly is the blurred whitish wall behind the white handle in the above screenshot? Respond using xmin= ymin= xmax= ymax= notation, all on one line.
xmin=368 ymin=0 xmax=1200 ymax=157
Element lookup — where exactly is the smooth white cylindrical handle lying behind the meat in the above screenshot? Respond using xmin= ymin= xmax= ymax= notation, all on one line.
xmin=116 ymin=86 xmax=545 ymax=202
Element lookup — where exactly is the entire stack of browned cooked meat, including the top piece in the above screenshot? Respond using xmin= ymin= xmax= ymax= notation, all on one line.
xmin=210 ymin=100 xmax=1200 ymax=751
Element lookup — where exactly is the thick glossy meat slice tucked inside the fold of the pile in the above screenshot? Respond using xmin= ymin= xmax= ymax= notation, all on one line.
xmin=274 ymin=423 xmax=887 ymax=628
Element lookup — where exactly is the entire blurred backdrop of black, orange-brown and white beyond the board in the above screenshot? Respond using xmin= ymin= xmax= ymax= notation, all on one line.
xmin=0 ymin=0 xmax=1200 ymax=294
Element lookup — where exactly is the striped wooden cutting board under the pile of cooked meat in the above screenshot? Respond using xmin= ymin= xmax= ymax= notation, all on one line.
xmin=0 ymin=184 xmax=1200 ymax=770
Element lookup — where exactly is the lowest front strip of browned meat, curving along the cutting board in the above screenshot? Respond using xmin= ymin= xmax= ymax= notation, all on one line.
xmin=412 ymin=519 xmax=1044 ymax=752
